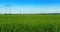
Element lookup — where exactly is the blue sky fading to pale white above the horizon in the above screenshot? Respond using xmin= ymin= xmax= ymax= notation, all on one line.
xmin=0 ymin=0 xmax=60 ymax=13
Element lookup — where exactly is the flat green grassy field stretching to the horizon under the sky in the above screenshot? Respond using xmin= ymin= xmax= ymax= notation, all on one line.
xmin=0 ymin=14 xmax=60 ymax=32
